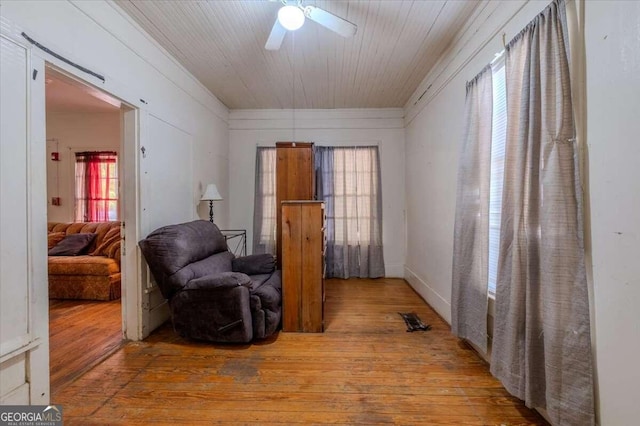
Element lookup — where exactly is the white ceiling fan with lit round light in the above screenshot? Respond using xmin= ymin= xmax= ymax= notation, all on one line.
xmin=264 ymin=0 xmax=358 ymax=50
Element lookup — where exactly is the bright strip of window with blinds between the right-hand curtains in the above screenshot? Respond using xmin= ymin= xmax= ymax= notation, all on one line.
xmin=488 ymin=57 xmax=507 ymax=294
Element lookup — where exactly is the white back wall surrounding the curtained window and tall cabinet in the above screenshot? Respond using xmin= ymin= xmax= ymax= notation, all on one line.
xmin=229 ymin=109 xmax=405 ymax=277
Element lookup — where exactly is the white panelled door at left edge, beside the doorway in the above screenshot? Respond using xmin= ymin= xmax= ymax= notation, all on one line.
xmin=0 ymin=36 xmax=49 ymax=404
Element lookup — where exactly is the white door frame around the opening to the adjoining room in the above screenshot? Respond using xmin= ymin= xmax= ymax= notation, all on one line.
xmin=0 ymin=19 xmax=148 ymax=405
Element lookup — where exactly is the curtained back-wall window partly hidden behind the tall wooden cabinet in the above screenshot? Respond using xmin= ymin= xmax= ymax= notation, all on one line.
xmin=253 ymin=146 xmax=384 ymax=278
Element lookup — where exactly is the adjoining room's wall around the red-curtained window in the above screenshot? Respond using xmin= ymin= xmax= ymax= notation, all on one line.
xmin=47 ymin=110 xmax=122 ymax=222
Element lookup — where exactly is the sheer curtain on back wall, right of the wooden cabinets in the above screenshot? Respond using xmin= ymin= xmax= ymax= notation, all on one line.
xmin=315 ymin=146 xmax=385 ymax=278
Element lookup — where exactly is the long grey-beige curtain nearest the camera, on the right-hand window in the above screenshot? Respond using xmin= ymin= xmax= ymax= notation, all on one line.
xmin=491 ymin=1 xmax=594 ymax=426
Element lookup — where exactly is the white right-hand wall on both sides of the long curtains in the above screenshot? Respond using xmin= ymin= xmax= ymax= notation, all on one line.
xmin=405 ymin=1 xmax=640 ymax=426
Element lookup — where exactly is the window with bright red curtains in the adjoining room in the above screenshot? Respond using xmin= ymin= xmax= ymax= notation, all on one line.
xmin=75 ymin=151 xmax=118 ymax=222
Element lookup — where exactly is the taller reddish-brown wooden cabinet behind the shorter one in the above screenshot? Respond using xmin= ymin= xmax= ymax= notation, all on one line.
xmin=276 ymin=142 xmax=315 ymax=267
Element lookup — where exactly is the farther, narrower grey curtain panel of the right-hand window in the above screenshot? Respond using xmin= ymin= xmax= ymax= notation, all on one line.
xmin=451 ymin=65 xmax=493 ymax=352
